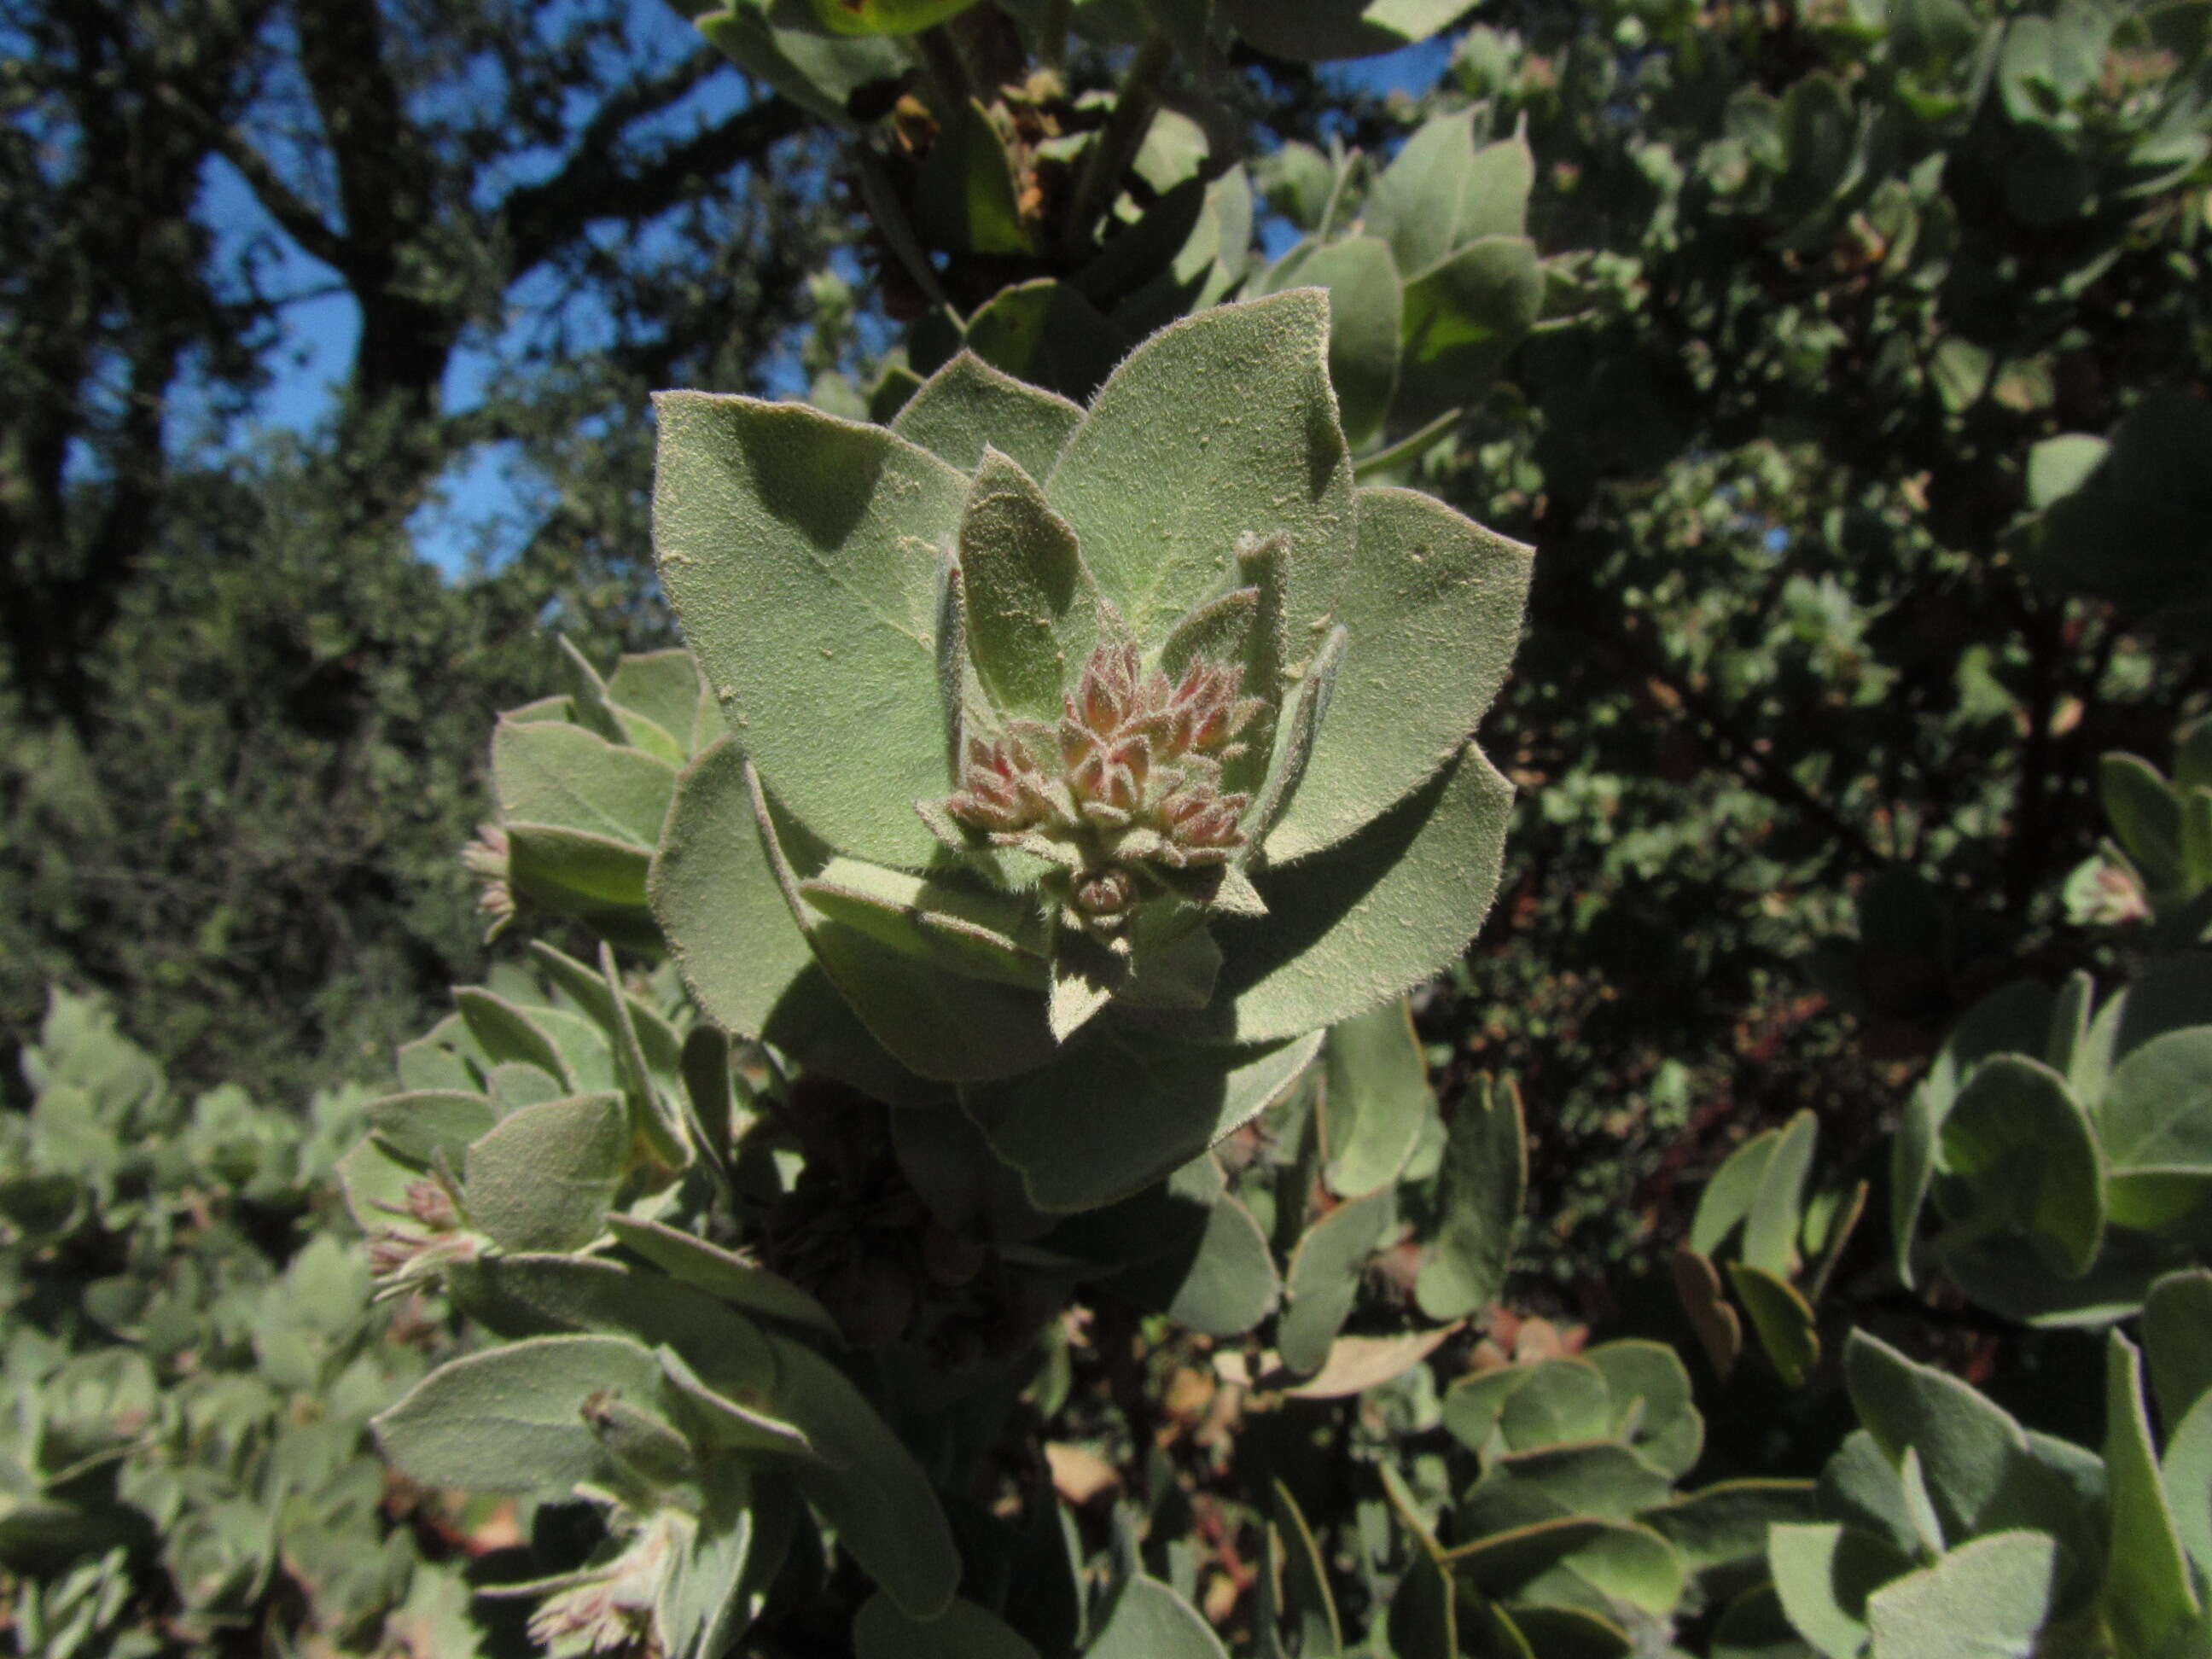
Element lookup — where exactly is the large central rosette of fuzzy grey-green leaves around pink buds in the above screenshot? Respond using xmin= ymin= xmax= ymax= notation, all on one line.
xmin=650 ymin=288 xmax=1528 ymax=1210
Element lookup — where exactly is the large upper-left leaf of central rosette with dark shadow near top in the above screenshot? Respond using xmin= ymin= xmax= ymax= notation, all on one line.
xmin=653 ymin=392 xmax=967 ymax=864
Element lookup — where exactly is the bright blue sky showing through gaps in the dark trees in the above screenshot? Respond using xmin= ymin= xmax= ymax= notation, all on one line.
xmin=199 ymin=11 xmax=1451 ymax=575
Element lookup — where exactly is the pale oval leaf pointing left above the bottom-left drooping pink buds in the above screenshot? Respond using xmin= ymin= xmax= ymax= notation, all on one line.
xmin=371 ymin=1336 xmax=661 ymax=1498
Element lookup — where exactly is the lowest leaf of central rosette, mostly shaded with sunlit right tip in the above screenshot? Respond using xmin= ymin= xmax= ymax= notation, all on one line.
xmin=960 ymin=1016 xmax=1320 ymax=1212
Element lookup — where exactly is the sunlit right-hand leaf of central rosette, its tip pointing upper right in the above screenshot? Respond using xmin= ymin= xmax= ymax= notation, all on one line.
xmin=1267 ymin=489 xmax=1531 ymax=864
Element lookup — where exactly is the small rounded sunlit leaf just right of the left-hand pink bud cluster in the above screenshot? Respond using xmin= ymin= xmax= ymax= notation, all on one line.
xmin=463 ymin=1095 xmax=631 ymax=1249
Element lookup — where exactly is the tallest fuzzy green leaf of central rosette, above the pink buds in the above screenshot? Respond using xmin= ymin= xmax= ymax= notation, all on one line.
xmin=1046 ymin=290 xmax=1353 ymax=664
